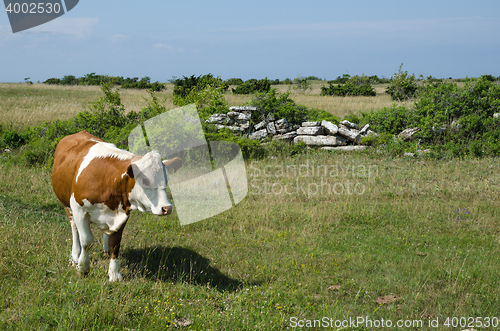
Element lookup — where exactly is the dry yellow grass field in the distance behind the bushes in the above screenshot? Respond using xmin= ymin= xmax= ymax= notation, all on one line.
xmin=0 ymin=82 xmax=412 ymax=129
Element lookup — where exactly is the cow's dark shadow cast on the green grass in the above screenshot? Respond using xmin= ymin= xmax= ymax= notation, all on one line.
xmin=120 ymin=245 xmax=254 ymax=291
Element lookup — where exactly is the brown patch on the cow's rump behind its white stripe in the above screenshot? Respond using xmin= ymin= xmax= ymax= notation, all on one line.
xmin=52 ymin=131 xmax=103 ymax=207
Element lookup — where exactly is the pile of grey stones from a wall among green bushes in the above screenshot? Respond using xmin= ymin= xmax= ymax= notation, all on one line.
xmin=206 ymin=107 xmax=377 ymax=150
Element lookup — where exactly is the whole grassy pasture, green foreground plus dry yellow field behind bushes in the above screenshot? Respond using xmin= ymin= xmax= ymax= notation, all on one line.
xmin=0 ymin=84 xmax=500 ymax=330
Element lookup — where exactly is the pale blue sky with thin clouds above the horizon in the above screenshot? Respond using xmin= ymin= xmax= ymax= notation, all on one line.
xmin=0 ymin=0 xmax=500 ymax=82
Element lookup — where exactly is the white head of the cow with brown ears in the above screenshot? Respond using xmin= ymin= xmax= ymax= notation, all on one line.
xmin=127 ymin=151 xmax=182 ymax=216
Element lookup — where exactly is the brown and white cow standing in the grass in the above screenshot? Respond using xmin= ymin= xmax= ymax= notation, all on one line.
xmin=52 ymin=131 xmax=182 ymax=282
